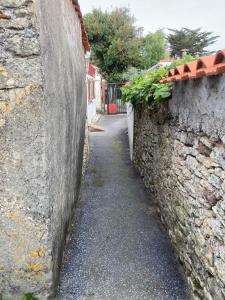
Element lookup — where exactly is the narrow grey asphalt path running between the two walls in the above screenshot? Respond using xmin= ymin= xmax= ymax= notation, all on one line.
xmin=58 ymin=116 xmax=187 ymax=300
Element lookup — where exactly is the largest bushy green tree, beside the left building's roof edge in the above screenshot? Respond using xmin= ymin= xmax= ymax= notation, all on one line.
xmin=84 ymin=8 xmax=141 ymax=81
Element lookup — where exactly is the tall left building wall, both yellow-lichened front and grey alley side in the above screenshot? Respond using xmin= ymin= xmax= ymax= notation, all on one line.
xmin=0 ymin=0 xmax=86 ymax=299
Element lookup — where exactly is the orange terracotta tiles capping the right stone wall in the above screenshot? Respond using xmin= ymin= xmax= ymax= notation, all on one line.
xmin=161 ymin=49 xmax=225 ymax=83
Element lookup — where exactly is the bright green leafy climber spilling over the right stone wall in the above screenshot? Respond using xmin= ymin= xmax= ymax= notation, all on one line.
xmin=122 ymin=68 xmax=172 ymax=109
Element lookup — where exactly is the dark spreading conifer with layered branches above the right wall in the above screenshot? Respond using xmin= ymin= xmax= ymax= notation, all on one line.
xmin=167 ymin=28 xmax=219 ymax=58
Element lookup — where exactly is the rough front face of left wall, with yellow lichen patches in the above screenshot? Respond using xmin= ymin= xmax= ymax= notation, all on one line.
xmin=0 ymin=0 xmax=51 ymax=297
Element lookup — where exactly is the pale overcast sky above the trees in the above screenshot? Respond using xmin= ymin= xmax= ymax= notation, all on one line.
xmin=79 ymin=0 xmax=225 ymax=50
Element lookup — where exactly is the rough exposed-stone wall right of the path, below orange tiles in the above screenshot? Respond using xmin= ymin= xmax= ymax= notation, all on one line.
xmin=134 ymin=75 xmax=225 ymax=300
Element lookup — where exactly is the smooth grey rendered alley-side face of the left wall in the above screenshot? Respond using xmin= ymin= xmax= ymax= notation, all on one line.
xmin=39 ymin=0 xmax=87 ymax=292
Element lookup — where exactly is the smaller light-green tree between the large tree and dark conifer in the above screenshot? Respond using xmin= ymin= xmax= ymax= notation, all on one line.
xmin=142 ymin=30 xmax=166 ymax=69
